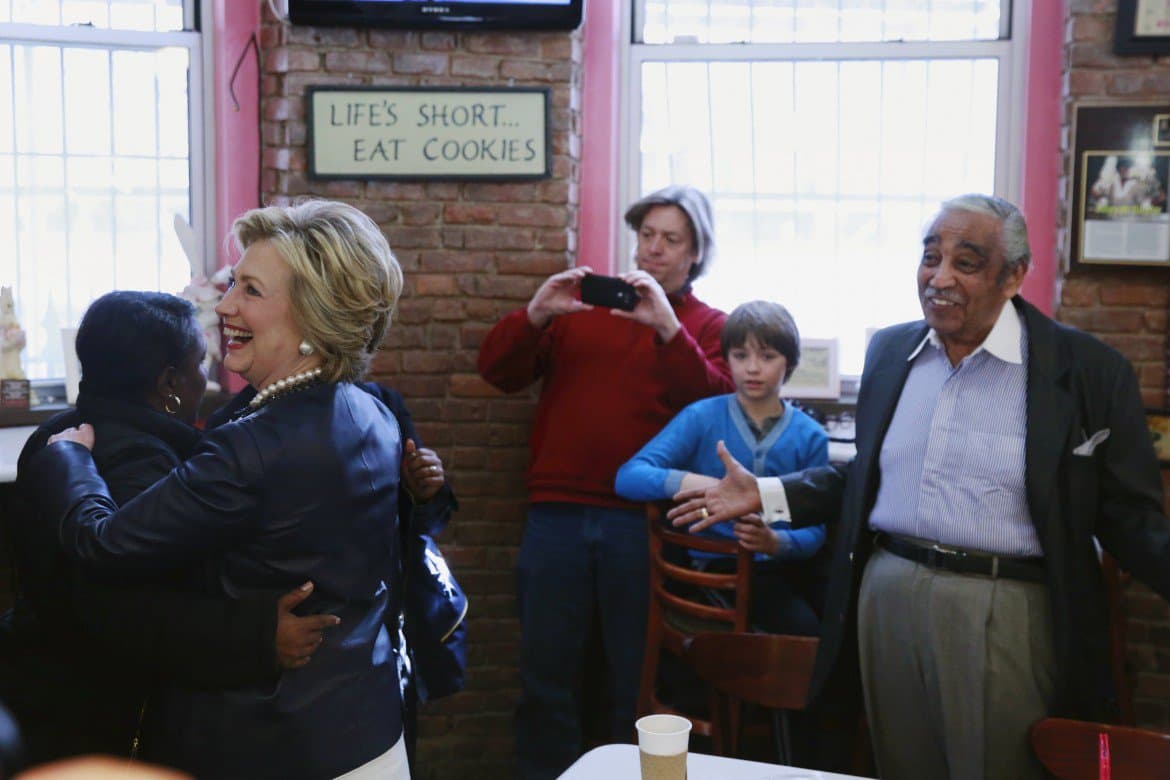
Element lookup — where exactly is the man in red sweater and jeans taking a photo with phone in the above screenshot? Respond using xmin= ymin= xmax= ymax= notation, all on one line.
xmin=479 ymin=186 xmax=732 ymax=780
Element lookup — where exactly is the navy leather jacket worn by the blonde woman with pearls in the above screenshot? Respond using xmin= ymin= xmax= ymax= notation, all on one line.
xmin=30 ymin=384 xmax=401 ymax=778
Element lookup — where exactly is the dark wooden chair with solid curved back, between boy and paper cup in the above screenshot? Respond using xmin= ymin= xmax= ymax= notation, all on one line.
xmin=684 ymin=633 xmax=820 ymax=764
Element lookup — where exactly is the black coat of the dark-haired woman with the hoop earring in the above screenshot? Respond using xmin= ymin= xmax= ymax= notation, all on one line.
xmin=7 ymin=391 xmax=280 ymax=764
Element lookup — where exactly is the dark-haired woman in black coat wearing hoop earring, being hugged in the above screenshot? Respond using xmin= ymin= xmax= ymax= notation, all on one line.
xmin=0 ymin=291 xmax=322 ymax=764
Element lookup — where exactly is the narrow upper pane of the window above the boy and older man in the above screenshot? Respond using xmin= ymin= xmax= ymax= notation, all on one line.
xmin=639 ymin=0 xmax=1002 ymax=43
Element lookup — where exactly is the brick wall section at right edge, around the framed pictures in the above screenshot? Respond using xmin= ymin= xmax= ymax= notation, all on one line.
xmin=1058 ymin=0 xmax=1170 ymax=729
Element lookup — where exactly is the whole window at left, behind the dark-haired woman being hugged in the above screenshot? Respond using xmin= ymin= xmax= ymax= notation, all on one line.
xmin=0 ymin=0 xmax=202 ymax=380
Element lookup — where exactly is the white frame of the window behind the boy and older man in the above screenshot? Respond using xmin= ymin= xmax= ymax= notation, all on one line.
xmin=614 ymin=0 xmax=1033 ymax=384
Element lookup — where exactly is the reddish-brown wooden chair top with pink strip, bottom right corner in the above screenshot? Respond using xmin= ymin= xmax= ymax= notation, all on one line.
xmin=1032 ymin=718 xmax=1170 ymax=780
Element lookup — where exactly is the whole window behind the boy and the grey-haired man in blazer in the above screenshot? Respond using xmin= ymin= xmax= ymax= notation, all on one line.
xmin=624 ymin=0 xmax=1024 ymax=374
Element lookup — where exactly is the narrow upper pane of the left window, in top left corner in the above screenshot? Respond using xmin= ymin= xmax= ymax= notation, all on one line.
xmin=0 ymin=0 xmax=183 ymax=33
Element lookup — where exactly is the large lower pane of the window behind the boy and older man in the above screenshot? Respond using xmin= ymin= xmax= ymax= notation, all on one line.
xmin=641 ymin=58 xmax=998 ymax=374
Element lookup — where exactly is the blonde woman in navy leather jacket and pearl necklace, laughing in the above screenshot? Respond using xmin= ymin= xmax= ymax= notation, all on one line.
xmin=32 ymin=201 xmax=410 ymax=778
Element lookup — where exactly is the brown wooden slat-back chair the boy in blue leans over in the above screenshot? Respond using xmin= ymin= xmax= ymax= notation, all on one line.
xmin=638 ymin=504 xmax=751 ymax=737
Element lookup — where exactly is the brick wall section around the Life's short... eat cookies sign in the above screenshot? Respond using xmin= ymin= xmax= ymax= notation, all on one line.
xmin=260 ymin=2 xmax=581 ymax=780
